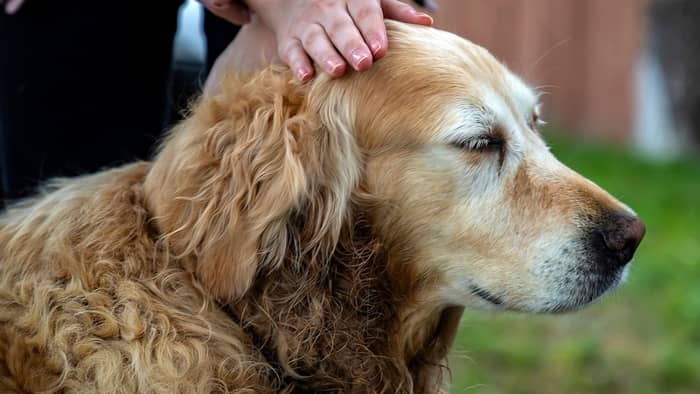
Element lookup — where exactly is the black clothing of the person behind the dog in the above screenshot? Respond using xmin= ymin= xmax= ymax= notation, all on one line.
xmin=0 ymin=0 xmax=238 ymax=199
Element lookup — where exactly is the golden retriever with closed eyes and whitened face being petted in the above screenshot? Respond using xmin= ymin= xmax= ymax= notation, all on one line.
xmin=0 ymin=22 xmax=645 ymax=393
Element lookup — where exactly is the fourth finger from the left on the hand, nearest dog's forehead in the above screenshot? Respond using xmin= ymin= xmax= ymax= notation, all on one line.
xmin=348 ymin=0 xmax=388 ymax=59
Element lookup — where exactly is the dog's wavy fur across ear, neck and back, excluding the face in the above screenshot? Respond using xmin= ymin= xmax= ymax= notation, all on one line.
xmin=0 ymin=25 xmax=462 ymax=393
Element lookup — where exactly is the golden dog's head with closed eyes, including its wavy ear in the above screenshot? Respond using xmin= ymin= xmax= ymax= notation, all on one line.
xmin=146 ymin=22 xmax=644 ymax=312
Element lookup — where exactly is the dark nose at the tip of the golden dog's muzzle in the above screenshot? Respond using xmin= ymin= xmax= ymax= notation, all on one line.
xmin=600 ymin=213 xmax=646 ymax=267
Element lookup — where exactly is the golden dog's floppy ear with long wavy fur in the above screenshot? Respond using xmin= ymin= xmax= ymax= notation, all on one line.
xmin=146 ymin=70 xmax=359 ymax=301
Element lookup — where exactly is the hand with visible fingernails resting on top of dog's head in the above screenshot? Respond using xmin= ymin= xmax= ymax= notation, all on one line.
xmin=247 ymin=0 xmax=433 ymax=82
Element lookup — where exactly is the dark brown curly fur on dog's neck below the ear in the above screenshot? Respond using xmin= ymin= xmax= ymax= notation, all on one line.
xmin=230 ymin=209 xmax=462 ymax=392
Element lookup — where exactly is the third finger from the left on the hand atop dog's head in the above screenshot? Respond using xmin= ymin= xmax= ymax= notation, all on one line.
xmin=323 ymin=13 xmax=372 ymax=71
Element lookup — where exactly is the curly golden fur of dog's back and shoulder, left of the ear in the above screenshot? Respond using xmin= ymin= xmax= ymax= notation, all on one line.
xmin=0 ymin=163 xmax=270 ymax=393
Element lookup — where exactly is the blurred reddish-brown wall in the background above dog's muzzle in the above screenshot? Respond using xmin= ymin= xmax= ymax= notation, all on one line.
xmin=436 ymin=0 xmax=644 ymax=140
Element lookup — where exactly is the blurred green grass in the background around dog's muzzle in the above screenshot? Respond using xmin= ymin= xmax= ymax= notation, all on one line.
xmin=450 ymin=133 xmax=700 ymax=394
